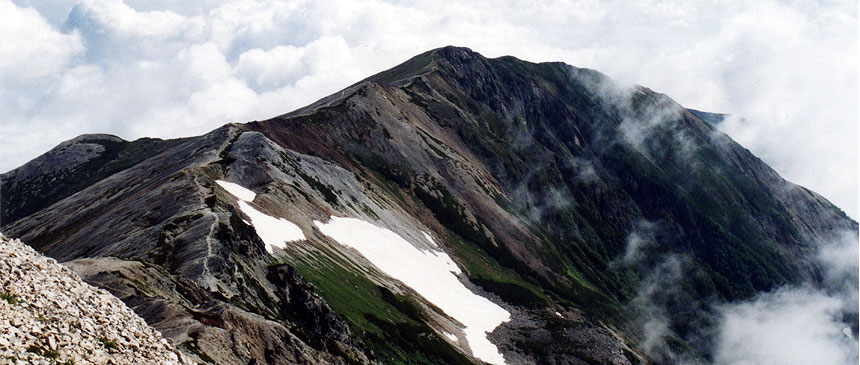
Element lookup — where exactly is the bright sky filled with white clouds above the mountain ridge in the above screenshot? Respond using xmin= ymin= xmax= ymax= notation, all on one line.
xmin=0 ymin=0 xmax=860 ymax=219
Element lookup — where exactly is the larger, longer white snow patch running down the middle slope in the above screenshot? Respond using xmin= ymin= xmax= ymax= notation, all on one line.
xmin=314 ymin=217 xmax=511 ymax=364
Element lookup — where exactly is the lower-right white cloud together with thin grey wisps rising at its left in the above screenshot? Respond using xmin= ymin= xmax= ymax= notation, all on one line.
xmin=621 ymin=229 xmax=860 ymax=365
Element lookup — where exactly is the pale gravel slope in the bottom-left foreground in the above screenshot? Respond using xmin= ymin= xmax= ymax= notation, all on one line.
xmin=0 ymin=235 xmax=192 ymax=364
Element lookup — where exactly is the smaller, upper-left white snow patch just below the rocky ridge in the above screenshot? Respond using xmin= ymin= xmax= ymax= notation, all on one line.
xmin=215 ymin=180 xmax=305 ymax=254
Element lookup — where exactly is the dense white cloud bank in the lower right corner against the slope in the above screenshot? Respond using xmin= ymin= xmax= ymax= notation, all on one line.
xmin=714 ymin=232 xmax=858 ymax=365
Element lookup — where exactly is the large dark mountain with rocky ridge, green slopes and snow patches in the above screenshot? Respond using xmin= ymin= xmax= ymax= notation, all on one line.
xmin=0 ymin=47 xmax=858 ymax=364
